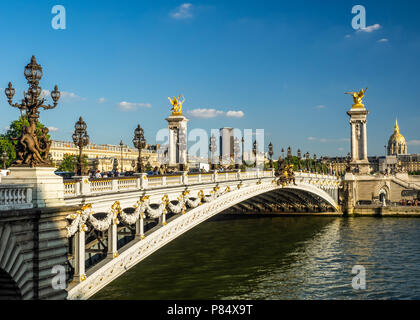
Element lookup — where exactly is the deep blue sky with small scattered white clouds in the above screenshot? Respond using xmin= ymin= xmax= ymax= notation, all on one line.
xmin=0 ymin=0 xmax=420 ymax=156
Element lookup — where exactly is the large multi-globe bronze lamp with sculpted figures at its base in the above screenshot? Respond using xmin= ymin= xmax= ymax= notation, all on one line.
xmin=4 ymin=56 xmax=60 ymax=167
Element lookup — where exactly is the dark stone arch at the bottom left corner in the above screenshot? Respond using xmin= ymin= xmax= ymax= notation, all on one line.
xmin=0 ymin=224 xmax=32 ymax=300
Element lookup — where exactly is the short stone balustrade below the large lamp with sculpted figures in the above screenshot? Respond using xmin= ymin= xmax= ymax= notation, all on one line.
xmin=0 ymin=184 xmax=33 ymax=211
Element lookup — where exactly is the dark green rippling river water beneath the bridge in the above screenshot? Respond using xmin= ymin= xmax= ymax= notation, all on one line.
xmin=92 ymin=217 xmax=420 ymax=299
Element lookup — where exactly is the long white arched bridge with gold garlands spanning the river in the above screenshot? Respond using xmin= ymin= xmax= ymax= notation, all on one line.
xmin=0 ymin=170 xmax=341 ymax=299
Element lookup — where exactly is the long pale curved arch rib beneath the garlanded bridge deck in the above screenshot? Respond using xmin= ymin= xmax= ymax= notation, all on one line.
xmin=67 ymin=179 xmax=339 ymax=299
